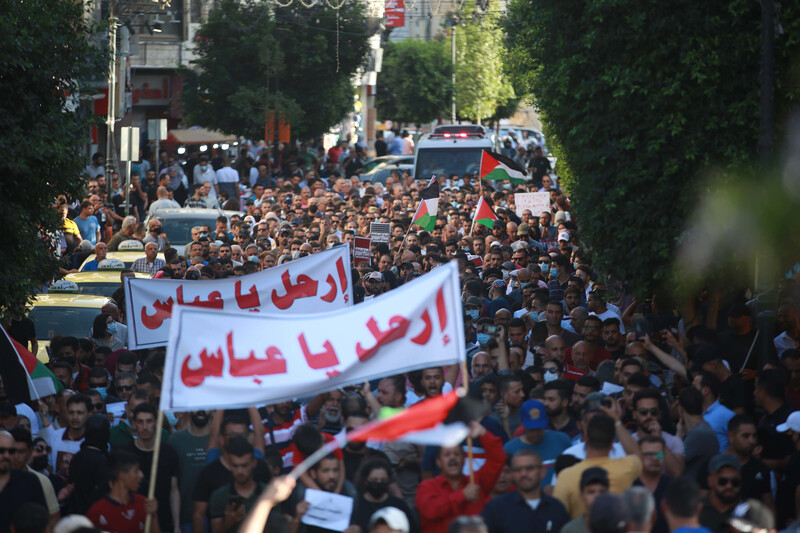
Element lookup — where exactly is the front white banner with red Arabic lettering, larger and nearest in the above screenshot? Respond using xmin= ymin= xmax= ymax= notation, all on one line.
xmin=161 ymin=261 xmax=466 ymax=411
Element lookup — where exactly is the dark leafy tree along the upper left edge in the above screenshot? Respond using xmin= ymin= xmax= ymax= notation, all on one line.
xmin=0 ymin=0 xmax=103 ymax=311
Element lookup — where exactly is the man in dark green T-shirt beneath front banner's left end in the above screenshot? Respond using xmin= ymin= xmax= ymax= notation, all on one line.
xmin=169 ymin=411 xmax=213 ymax=531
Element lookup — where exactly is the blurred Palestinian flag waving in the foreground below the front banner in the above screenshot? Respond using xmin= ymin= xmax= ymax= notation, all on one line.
xmin=347 ymin=391 xmax=483 ymax=446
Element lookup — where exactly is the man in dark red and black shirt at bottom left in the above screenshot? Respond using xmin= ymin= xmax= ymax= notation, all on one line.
xmin=86 ymin=451 xmax=159 ymax=533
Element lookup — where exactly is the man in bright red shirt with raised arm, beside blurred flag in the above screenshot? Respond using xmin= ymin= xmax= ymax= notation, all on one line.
xmin=416 ymin=422 xmax=506 ymax=533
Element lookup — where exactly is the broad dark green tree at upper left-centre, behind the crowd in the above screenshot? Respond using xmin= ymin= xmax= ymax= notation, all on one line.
xmin=183 ymin=0 xmax=368 ymax=139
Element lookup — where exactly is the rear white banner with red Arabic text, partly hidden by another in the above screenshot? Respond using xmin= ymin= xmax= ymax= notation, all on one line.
xmin=125 ymin=246 xmax=353 ymax=350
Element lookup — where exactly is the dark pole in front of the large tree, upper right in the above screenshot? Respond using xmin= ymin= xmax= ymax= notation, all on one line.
xmin=758 ymin=0 xmax=775 ymax=164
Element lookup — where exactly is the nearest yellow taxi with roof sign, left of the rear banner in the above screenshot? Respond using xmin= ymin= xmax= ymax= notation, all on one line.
xmin=28 ymin=273 xmax=111 ymax=363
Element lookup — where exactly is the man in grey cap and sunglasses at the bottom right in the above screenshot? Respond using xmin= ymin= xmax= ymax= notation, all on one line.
xmin=700 ymin=453 xmax=742 ymax=533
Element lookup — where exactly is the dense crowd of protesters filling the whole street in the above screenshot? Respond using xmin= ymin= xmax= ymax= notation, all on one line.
xmin=0 ymin=136 xmax=800 ymax=533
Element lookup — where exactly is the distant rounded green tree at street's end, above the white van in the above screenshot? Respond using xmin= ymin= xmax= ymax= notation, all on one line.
xmin=377 ymin=39 xmax=453 ymax=125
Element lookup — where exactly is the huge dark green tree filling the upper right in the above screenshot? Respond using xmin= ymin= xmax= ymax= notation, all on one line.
xmin=504 ymin=0 xmax=800 ymax=293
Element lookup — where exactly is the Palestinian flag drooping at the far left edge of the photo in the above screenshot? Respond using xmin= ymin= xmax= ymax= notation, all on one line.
xmin=0 ymin=326 xmax=64 ymax=405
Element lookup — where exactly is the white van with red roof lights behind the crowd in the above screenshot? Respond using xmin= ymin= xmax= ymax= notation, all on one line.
xmin=414 ymin=124 xmax=497 ymax=179
